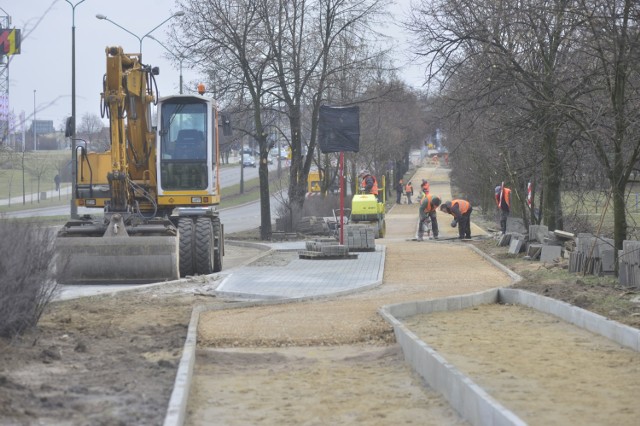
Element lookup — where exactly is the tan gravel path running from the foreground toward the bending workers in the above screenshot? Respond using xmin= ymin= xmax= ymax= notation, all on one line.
xmin=187 ymin=168 xmax=509 ymax=425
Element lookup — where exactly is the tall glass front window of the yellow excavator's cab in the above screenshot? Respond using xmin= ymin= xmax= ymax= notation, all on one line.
xmin=160 ymin=99 xmax=213 ymax=190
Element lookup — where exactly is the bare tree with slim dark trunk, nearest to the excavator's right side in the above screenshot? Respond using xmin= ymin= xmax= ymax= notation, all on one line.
xmin=180 ymin=0 xmax=271 ymax=240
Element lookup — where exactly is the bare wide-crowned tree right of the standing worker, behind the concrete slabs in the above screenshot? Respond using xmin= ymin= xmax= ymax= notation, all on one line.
xmin=409 ymin=0 xmax=583 ymax=229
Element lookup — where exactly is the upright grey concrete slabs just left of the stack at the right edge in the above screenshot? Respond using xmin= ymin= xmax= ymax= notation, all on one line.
xmin=569 ymin=233 xmax=615 ymax=276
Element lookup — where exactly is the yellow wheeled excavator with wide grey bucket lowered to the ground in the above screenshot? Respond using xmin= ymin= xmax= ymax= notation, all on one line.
xmin=56 ymin=47 xmax=228 ymax=284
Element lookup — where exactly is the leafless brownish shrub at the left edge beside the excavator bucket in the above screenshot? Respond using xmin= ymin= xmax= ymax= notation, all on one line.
xmin=0 ymin=220 xmax=57 ymax=337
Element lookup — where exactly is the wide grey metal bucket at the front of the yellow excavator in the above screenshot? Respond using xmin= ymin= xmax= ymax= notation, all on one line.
xmin=56 ymin=218 xmax=180 ymax=284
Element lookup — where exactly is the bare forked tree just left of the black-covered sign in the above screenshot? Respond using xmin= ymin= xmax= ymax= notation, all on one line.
xmin=262 ymin=0 xmax=385 ymax=209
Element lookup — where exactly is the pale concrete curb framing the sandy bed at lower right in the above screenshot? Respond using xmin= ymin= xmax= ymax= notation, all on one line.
xmin=379 ymin=246 xmax=640 ymax=425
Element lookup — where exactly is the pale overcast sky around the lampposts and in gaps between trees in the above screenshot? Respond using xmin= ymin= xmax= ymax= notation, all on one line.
xmin=6 ymin=0 xmax=422 ymax=129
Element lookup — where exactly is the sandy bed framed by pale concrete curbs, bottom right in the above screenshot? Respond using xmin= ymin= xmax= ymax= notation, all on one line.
xmin=405 ymin=304 xmax=640 ymax=426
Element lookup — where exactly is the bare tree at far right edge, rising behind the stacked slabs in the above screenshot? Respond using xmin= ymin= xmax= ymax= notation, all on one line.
xmin=568 ymin=0 xmax=640 ymax=249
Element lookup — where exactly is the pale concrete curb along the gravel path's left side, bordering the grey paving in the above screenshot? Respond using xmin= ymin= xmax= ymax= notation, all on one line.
xmin=163 ymin=243 xmax=386 ymax=426
